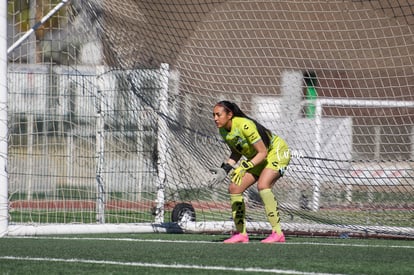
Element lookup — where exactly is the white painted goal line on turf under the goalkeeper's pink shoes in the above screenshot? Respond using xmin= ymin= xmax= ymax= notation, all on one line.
xmin=4 ymin=236 xmax=414 ymax=249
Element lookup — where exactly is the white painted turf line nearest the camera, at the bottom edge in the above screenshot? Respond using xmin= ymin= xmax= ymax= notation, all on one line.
xmin=0 ymin=256 xmax=348 ymax=275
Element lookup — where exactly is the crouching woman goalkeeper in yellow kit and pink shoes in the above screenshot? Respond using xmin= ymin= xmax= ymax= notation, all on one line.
xmin=211 ymin=101 xmax=290 ymax=243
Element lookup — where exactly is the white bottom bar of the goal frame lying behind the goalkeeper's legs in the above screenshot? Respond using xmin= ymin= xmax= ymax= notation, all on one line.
xmin=5 ymin=221 xmax=414 ymax=239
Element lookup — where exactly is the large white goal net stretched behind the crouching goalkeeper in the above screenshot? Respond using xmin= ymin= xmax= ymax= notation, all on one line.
xmin=0 ymin=0 xmax=414 ymax=238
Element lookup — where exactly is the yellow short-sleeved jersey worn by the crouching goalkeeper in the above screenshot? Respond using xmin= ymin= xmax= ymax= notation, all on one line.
xmin=219 ymin=117 xmax=268 ymax=159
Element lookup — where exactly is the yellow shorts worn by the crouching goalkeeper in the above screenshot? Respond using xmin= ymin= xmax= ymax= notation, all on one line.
xmin=249 ymin=136 xmax=290 ymax=177
